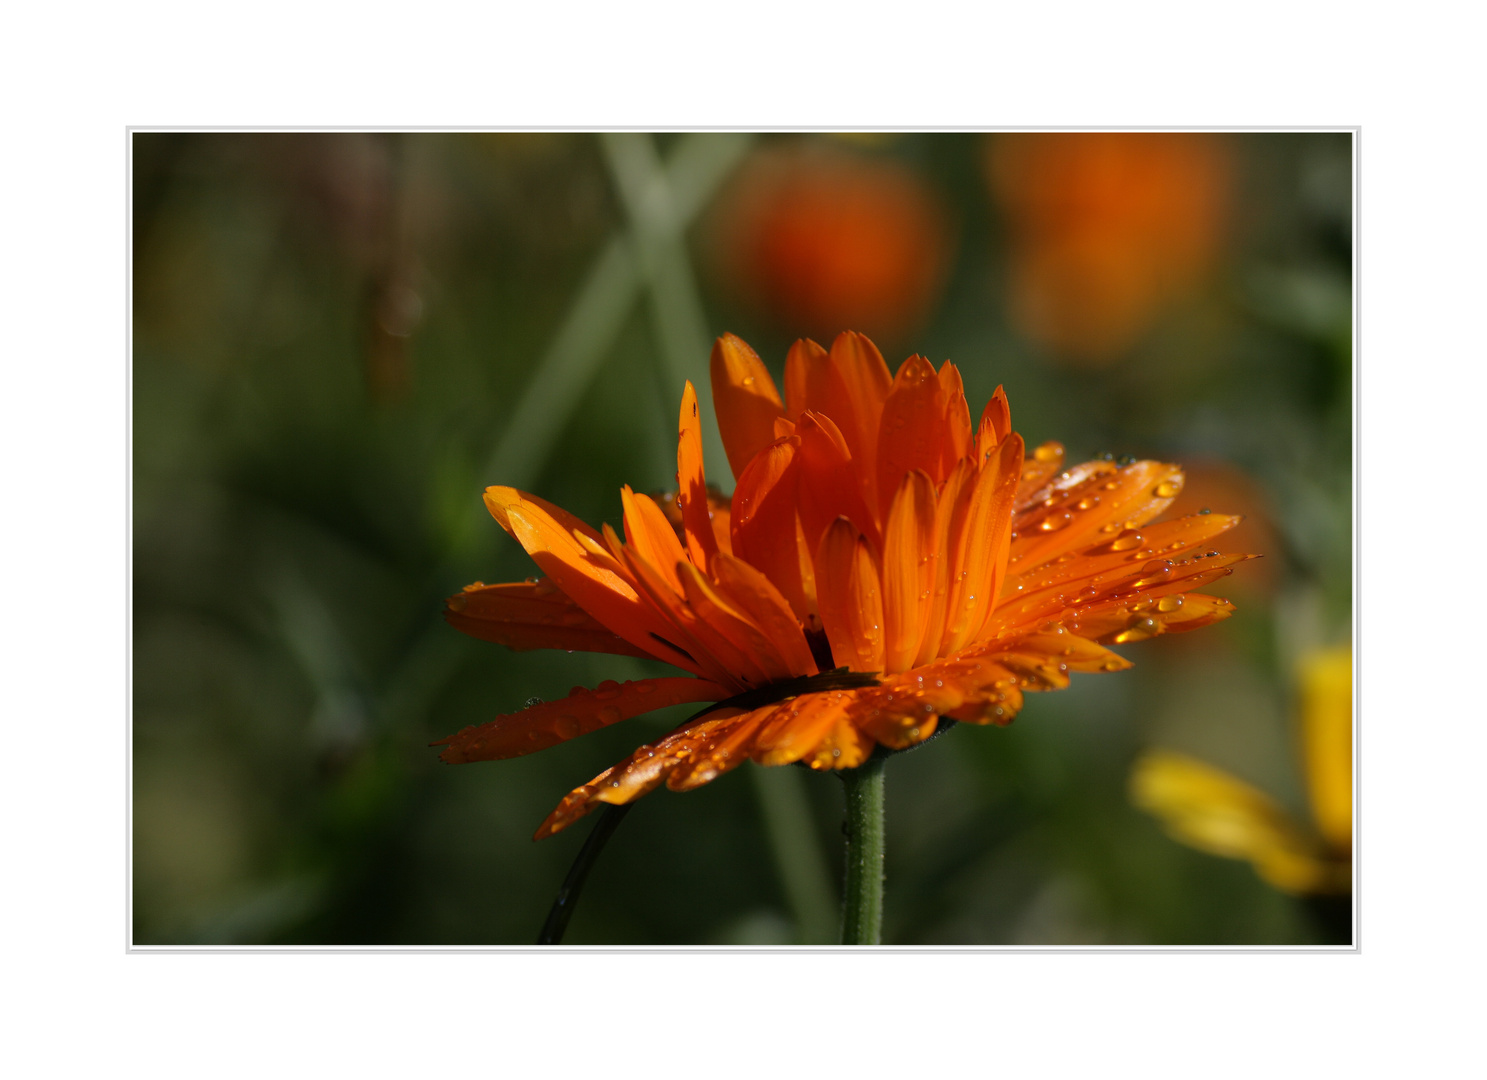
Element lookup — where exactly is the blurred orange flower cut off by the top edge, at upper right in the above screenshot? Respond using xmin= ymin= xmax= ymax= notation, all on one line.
xmin=986 ymin=132 xmax=1231 ymax=366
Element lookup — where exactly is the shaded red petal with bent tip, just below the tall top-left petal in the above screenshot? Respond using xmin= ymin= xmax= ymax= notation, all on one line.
xmin=732 ymin=436 xmax=815 ymax=623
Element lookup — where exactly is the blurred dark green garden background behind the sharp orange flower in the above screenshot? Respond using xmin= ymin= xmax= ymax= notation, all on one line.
xmin=132 ymin=132 xmax=1353 ymax=945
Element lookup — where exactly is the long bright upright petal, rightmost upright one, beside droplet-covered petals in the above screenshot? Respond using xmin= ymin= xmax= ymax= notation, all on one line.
xmin=940 ymin=434 xmax=1023 ymax=653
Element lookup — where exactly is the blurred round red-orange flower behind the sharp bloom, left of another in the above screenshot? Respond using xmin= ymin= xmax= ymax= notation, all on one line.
xmin=714 ymin=143 xmax=950 ymax=342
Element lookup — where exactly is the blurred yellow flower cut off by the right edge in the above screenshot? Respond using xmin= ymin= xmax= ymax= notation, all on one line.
xmin=1130 ymin=647 xmax=1353 ymax=894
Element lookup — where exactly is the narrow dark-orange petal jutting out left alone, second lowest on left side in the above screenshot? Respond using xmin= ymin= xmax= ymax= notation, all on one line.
xmin=433 ymin=678 xmax=730 ymax=765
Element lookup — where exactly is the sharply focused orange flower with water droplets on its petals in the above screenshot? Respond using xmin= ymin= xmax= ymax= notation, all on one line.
xmin=439 ymin=333 xmax=1249 ymax=838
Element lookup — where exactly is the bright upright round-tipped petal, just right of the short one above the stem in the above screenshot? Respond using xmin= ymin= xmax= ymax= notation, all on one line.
xmin=882 ymin=470 xmax=935 ymax=672
